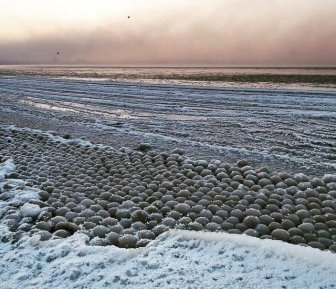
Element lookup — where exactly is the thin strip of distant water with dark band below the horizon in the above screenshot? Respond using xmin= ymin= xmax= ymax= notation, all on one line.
xmin=0 ymin=65 xmax=336 ymax=90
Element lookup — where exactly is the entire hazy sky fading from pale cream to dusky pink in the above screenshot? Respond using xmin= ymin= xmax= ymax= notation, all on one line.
xmin=0 ymin=0 xmax=336 ymax=66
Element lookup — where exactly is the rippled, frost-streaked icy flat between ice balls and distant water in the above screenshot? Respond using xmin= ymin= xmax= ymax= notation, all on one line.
xmin=0 ymin=75 xmax=336 ymax=176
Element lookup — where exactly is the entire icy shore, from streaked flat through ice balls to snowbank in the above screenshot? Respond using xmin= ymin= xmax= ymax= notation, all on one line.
xmin=0 ymin=68 xmax=336 ymax=288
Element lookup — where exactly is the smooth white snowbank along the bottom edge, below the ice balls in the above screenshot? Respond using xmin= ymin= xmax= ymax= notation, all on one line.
xmin=0 ymin=230 xmax=336 ymax=289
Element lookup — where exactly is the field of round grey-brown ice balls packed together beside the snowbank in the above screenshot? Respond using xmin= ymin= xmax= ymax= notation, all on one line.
xmin=0 ymin=129 xmax=336 ymax=252
